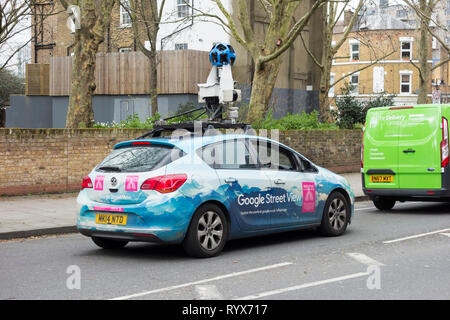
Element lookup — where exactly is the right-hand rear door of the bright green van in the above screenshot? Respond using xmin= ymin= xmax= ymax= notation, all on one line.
xmin=398 ymin=106 xmax=442 ymax=189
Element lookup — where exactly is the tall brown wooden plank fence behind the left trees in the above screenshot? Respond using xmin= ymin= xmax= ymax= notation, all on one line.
xmin=45 ymin=50 xmax=211 ymax=96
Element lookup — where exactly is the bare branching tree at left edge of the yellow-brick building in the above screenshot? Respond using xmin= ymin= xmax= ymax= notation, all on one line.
xmin=300 ymin=0 xmax=396 ymax=122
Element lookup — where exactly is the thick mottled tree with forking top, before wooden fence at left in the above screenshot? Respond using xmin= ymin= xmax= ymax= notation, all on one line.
xmin=60 ymin=0 xmax=116 ymax=128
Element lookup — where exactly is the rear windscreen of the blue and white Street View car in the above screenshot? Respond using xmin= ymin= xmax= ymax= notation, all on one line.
xmin=96 ymin=145 xmax=185 ymax=172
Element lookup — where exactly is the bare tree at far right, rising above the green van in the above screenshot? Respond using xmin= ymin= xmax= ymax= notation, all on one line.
xmin=404 ymin=0 xmax=450 ymax=104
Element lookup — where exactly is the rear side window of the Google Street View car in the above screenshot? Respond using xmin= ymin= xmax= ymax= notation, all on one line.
xmin=199 ymin=140 xmax=258 ymax=169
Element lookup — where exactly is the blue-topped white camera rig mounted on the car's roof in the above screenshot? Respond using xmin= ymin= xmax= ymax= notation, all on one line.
xmin=138 ymin=43 xmax=251 ymax=139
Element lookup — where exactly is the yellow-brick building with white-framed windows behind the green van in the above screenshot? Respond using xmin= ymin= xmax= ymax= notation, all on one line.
xmin=329 ymin=3 xmax=433 ymax=106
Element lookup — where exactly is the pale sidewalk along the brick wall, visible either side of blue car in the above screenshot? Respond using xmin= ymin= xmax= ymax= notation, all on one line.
xmin=0 ymin=173 xmax=364 ymax=240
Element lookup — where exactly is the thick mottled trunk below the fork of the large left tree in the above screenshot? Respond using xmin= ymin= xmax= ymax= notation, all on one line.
xmin=66 ymin=30 xmax=99 ymax=128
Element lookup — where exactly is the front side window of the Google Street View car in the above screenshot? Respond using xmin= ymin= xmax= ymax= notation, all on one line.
xmin=251 ymin=140 xmax=297 ymax=171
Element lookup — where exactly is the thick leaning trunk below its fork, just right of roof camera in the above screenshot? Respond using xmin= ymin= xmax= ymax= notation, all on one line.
xmin=247 ymin=58 xmax=281 ymax=124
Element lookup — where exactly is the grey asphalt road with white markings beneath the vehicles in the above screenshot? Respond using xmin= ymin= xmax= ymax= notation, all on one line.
xmin=0 ymin=202 xmax=450 ymax=300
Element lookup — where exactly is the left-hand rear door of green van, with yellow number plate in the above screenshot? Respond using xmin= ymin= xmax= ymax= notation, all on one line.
xmin=363 ymin=107 xmax=404 ymax=189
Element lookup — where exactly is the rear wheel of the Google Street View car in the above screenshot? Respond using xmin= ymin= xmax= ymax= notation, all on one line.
xmin=183 ymin=203 xmax=228 ymax=258
